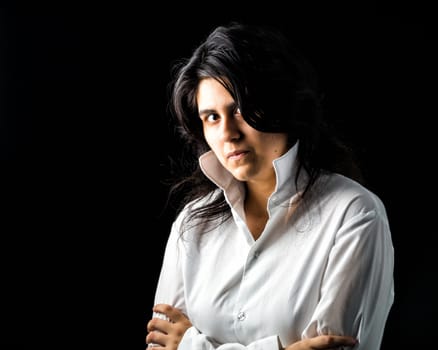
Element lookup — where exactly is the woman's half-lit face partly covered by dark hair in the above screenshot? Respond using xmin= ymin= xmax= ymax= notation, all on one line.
xmin=196 ymin=78 xmax=288 ymax=181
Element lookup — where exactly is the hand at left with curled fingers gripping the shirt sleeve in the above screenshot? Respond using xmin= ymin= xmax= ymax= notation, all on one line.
xmin=146 ymin=304 xmax=192 ymax=350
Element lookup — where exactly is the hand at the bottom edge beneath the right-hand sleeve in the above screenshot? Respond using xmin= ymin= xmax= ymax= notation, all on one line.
xmin=284 ymin=335 xmax=357 ymax=350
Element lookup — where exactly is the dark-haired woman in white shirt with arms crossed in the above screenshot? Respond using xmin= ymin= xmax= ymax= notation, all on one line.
xmin=146 ymin=23 xmax=394 ymax=350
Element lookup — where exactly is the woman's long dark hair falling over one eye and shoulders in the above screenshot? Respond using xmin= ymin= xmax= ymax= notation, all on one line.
xmin=161 ymin=22 xmax=361 ymax=230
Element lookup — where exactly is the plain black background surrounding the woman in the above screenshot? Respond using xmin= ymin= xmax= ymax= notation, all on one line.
xmin=0 ymin=1 xmax=437 ymax=350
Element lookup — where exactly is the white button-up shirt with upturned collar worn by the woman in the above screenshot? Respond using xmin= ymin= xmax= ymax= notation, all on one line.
xmin=155 ymin=144 xmax=394 ymax=350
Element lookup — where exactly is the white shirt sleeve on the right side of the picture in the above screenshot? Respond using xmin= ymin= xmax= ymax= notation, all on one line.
xmin=303 ymin=206 xmax=394 ymax=350
